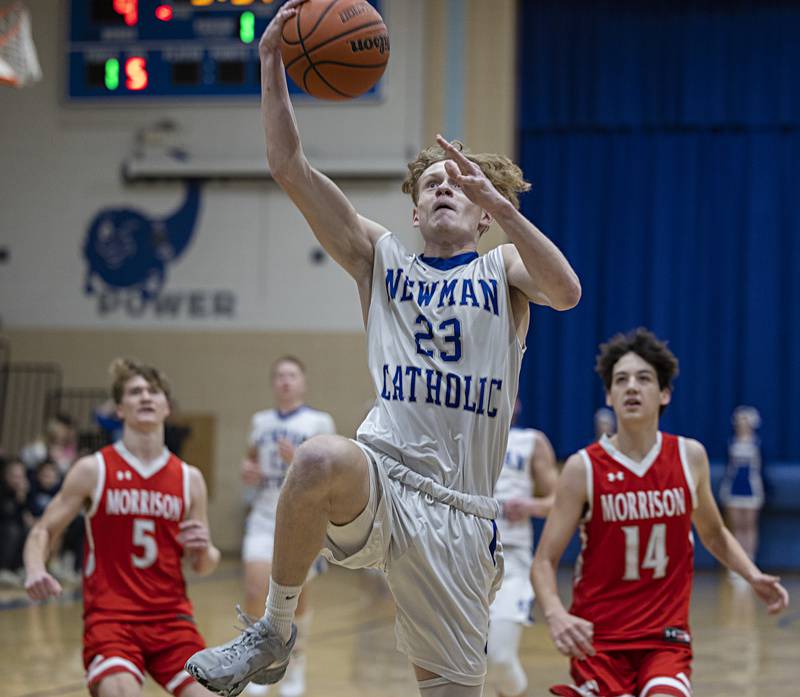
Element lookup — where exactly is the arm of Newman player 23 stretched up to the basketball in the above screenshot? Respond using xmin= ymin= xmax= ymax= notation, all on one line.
xmin=259 ymin=0 xmax=384 ymax=288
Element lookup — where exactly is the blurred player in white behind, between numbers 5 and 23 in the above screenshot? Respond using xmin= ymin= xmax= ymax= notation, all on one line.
xmin=242 ymin=356 xmax=336 ymax=697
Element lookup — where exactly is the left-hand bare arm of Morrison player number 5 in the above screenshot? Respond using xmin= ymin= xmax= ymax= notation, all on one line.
xmin=23 ymin=456 xmax=98 ymax=600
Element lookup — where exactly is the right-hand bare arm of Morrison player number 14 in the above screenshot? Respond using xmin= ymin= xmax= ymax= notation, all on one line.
xmin=686 ymin=438 xmax=789 ymax=614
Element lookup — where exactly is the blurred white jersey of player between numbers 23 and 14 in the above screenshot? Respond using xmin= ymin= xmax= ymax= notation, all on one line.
xmin=494 ymin=428 xmax=536 ymax=549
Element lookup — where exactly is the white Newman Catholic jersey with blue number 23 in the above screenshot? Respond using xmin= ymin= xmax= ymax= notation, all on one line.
xmin=357 ymin=233 xmax=524 ymax=496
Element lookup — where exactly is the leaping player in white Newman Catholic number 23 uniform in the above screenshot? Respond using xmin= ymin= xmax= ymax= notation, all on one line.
xmin=187 ymin=0 xmax=580 ymax=697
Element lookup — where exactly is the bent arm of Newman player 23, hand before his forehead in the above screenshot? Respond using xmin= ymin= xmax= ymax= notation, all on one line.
xmin=436 ymin=136 xmax=581 ymax=310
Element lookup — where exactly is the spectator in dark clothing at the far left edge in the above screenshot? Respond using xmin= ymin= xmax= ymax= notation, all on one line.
xmin=0 ymin=459 xmax=33 ymax=585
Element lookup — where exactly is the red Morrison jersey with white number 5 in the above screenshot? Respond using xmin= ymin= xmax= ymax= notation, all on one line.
xmin=83 ymin=443 xmax=192 ymax=622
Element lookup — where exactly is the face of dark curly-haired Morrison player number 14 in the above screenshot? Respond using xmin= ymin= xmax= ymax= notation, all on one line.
xmin=606 ymin=352 xmax=672 ymax=423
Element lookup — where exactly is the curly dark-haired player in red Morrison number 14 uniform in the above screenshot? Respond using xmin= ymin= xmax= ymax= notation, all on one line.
xmin=531 ymin=329 xmax=789 ymax=697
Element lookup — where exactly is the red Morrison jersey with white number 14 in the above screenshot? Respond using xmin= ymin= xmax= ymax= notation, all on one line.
xmin=570 ymin=433 xmax=696 ymax=649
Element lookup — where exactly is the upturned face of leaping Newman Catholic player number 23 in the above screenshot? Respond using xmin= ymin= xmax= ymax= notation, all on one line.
xmin=413 ymin=162 xmax=491 ymax=242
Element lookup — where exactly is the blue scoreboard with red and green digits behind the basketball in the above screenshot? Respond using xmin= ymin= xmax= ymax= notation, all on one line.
xmin=67 ymin=0 xmax=380 ymax=103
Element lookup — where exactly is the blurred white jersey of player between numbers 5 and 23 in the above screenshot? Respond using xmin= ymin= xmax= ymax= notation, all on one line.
xmin=249 ymin=406 xmax=336 ymax=511
